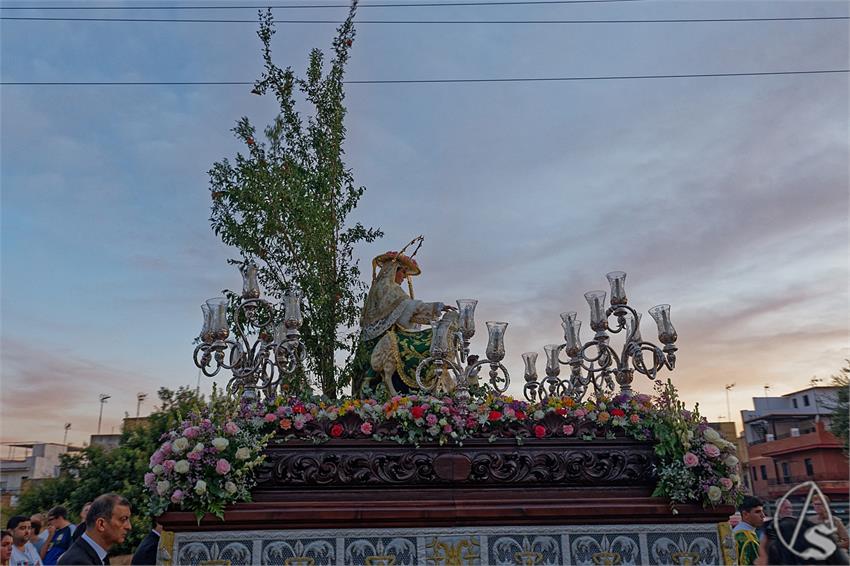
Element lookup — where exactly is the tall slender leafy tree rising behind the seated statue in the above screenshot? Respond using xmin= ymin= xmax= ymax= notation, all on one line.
xmin=209 ymin=2 xmax=383 ymax=398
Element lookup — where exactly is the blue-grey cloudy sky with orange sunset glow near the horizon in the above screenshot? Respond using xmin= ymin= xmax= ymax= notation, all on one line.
xmin=0 ymin=0 xmax=850 ymax=444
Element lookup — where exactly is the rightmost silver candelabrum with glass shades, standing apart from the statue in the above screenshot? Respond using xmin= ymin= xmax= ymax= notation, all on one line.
xmin=523 ymin=271 xmax=678 ymax=402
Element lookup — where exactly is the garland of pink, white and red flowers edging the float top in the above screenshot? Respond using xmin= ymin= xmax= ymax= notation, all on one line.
xmin=145 ymin=382 xmax=742 ymax=520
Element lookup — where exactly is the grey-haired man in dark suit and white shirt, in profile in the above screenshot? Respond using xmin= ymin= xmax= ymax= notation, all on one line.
xmin=57 ymin=493 xmax=131 ymax=566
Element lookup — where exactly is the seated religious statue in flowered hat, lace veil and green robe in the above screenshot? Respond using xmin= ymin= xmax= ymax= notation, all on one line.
xmin=352 ymin=236 xmax=457 ymax=396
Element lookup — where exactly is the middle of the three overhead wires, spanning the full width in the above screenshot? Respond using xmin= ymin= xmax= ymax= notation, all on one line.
xmin=0 ymin=16 xmax=850 ymax=25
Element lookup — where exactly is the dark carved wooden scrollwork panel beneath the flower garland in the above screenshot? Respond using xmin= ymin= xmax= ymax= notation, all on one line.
xmin=256 ymin=439 xmax=655 ymax=491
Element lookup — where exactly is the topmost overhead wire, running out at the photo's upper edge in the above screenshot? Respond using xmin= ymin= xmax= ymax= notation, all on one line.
xmin=0 ymin=0 xmax=649 ymax=10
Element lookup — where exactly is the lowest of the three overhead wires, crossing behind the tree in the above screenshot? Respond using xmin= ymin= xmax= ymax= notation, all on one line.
xmin=0 ymin=69 xmax=850 ymax=86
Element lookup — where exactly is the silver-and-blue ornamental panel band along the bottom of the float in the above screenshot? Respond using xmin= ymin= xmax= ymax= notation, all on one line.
xmin=171 ymin=523 xmax=734 ymax=566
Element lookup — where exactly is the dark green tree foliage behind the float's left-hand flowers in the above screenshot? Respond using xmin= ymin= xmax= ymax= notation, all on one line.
xmin=12 ymin=387 xmax=207 ymax=554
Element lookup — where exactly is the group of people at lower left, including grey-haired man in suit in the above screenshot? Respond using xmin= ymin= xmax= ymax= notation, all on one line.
xmin=0 ymin=493 xmax=162 ymax=566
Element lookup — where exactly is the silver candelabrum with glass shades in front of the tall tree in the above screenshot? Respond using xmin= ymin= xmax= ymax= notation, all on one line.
xmin=192 ymin=262 xmax=307 ymax=399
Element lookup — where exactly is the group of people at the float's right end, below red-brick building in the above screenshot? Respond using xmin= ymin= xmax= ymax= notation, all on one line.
xmin=730 ymin=495 xmax=850 ymax=566
